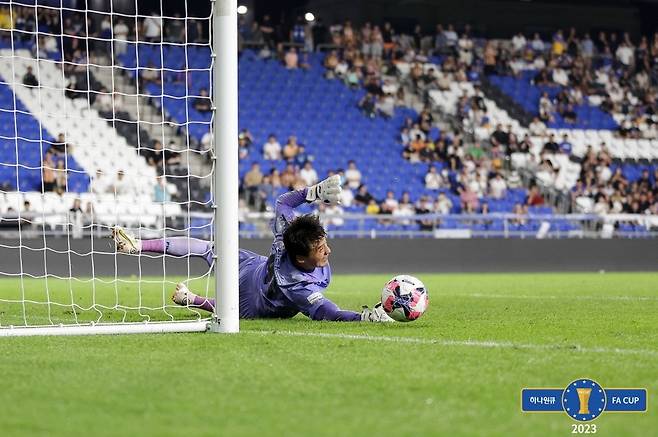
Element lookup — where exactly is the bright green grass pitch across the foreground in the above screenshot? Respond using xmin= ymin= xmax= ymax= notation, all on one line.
xmin=0 ymin=273 xmax=658 ymax=436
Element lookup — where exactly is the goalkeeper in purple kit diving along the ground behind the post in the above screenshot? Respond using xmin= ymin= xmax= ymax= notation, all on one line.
xmin=112 ymin=175 xmax=392 ymax=322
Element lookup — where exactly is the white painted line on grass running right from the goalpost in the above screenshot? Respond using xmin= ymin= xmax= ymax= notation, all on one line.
xmin=240 ymin=329 xmax=658 ymax=357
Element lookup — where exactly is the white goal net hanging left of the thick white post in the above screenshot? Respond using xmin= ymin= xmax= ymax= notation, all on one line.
xmin=0 ymin=0 xmax=226 ymax=335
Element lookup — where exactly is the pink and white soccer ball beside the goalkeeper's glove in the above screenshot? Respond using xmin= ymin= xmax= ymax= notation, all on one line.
xmin=382 ymin=275 xmax=430 ymax=322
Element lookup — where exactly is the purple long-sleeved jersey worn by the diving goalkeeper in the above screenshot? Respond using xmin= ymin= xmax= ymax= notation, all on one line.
xmin=240 ymin=189 xmax=361 ymax=321
